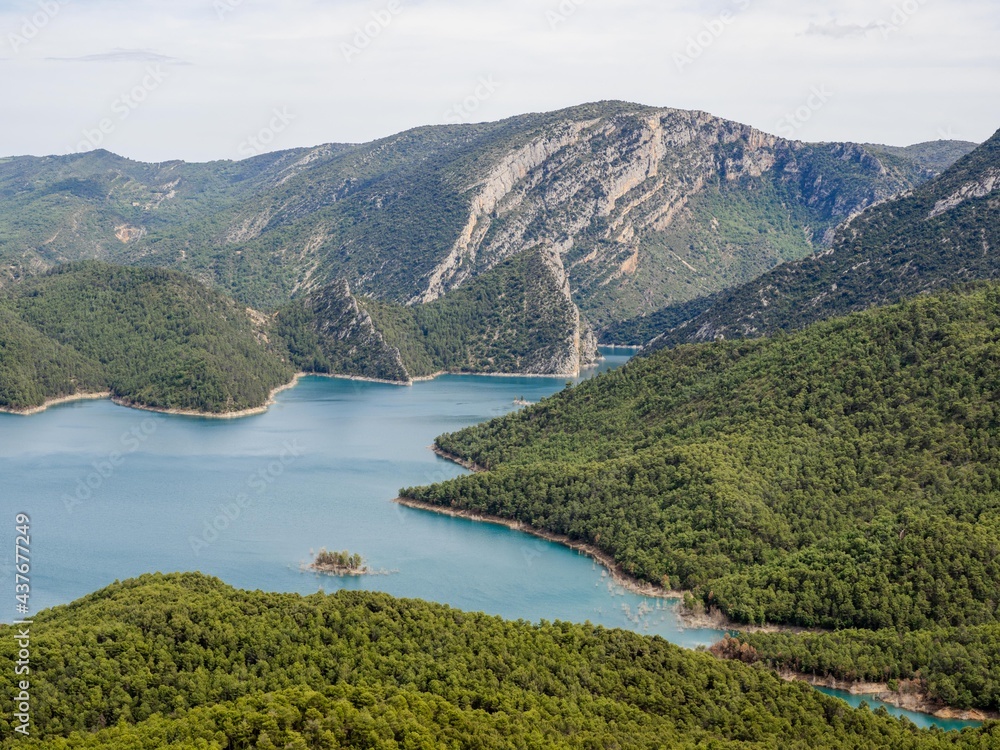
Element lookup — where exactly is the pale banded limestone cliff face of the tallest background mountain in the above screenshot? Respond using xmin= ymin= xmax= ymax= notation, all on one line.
xmin=412 ymin=108 xmax=909 ymax=328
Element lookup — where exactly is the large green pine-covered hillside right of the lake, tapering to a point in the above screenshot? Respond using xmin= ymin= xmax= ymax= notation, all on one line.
xmin=403 ymin=285 xmax=1000 ymax=704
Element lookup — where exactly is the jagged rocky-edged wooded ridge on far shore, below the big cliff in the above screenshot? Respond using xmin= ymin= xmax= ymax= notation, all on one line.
xmin=275 ymin=249 xmax=598 ymax=382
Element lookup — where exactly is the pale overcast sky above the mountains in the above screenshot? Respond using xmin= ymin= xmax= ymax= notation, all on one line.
xmin=0 ymin=0 xmax=1000 ymax=161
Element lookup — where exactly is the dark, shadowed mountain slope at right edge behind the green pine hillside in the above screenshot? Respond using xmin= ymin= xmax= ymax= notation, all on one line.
xmin=632 ymin=132 xmax=1000 ymax=348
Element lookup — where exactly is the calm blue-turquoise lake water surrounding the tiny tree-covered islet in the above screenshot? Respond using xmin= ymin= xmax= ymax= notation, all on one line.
xmin=0 ymin=350 xmax=980 ymax=728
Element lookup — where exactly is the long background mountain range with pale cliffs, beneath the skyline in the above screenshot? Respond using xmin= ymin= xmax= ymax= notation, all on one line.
xmin=0 ymin=102 xmax=961 ymax=328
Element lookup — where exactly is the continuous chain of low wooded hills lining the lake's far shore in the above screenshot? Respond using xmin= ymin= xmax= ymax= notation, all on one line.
xmin=0 ymin=250 xmax=598 ymax=414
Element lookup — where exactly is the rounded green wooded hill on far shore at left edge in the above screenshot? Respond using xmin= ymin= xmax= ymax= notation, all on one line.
xmin=0 ymin=261 xmax=293 ymax=414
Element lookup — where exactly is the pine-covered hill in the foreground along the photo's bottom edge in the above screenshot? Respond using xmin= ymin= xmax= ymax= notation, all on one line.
xmin=0 ymin=574 xmax=1000 ymax=750
